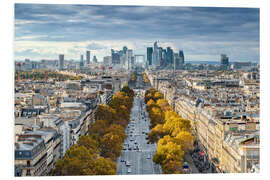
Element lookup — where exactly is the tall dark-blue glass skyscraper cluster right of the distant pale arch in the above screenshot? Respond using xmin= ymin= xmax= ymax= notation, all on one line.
xmin=147 ymin=41 xmax=185 ymax=69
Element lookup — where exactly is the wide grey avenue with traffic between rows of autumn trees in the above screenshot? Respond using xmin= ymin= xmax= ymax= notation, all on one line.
xmin=117 ymin=93 xmax=161 ymax=175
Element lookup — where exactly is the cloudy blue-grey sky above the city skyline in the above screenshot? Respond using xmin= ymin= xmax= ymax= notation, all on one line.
xmin=14 ymin=4 xmax=260 ymax=62
